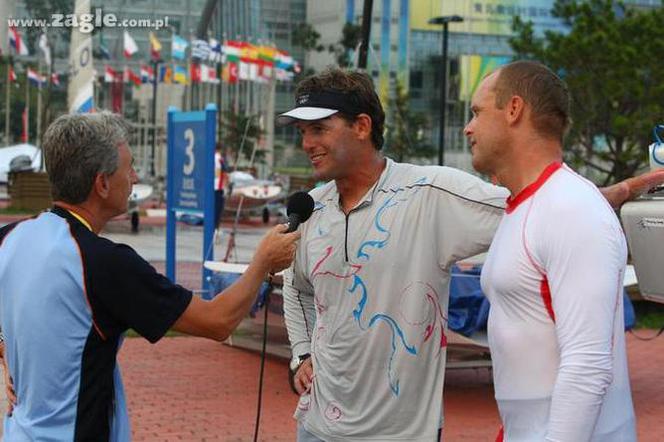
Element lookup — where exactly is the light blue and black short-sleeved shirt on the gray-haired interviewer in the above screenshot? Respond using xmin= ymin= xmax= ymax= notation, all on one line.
xmin=0 ymin=206 xmax=192 ymax=441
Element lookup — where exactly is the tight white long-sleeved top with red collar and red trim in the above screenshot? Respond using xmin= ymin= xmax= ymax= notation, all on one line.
xmin=481 ymin=163 xmax=636 ymax=442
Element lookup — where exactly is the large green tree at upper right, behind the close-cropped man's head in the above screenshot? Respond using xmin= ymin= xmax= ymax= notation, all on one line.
xmin=510 ymin=0 xmax=664 ymax=184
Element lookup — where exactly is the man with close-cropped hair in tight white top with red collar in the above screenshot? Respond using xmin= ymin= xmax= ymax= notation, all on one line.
xmin=464 ymin=61 xmax=636 ymax=442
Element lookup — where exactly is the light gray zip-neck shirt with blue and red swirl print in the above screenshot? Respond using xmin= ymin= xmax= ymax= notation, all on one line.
xmin=283 ymin=160 xmax=507 ymax=442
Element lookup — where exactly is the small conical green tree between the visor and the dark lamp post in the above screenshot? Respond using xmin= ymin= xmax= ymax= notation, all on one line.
xmin=385 ymin=81 xmax=436 ymax=162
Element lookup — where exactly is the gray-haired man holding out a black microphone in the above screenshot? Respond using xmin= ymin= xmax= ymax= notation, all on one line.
xmin=0 ymin=112 xmax=298 ymax=441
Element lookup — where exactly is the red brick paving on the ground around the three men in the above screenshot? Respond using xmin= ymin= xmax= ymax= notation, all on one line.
xmin=120 ymin=331 xmax=664 ymax=442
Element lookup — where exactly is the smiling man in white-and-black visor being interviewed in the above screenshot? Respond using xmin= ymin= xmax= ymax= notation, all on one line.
xmin=277 ymin=69 xmax=664 ymax=442
